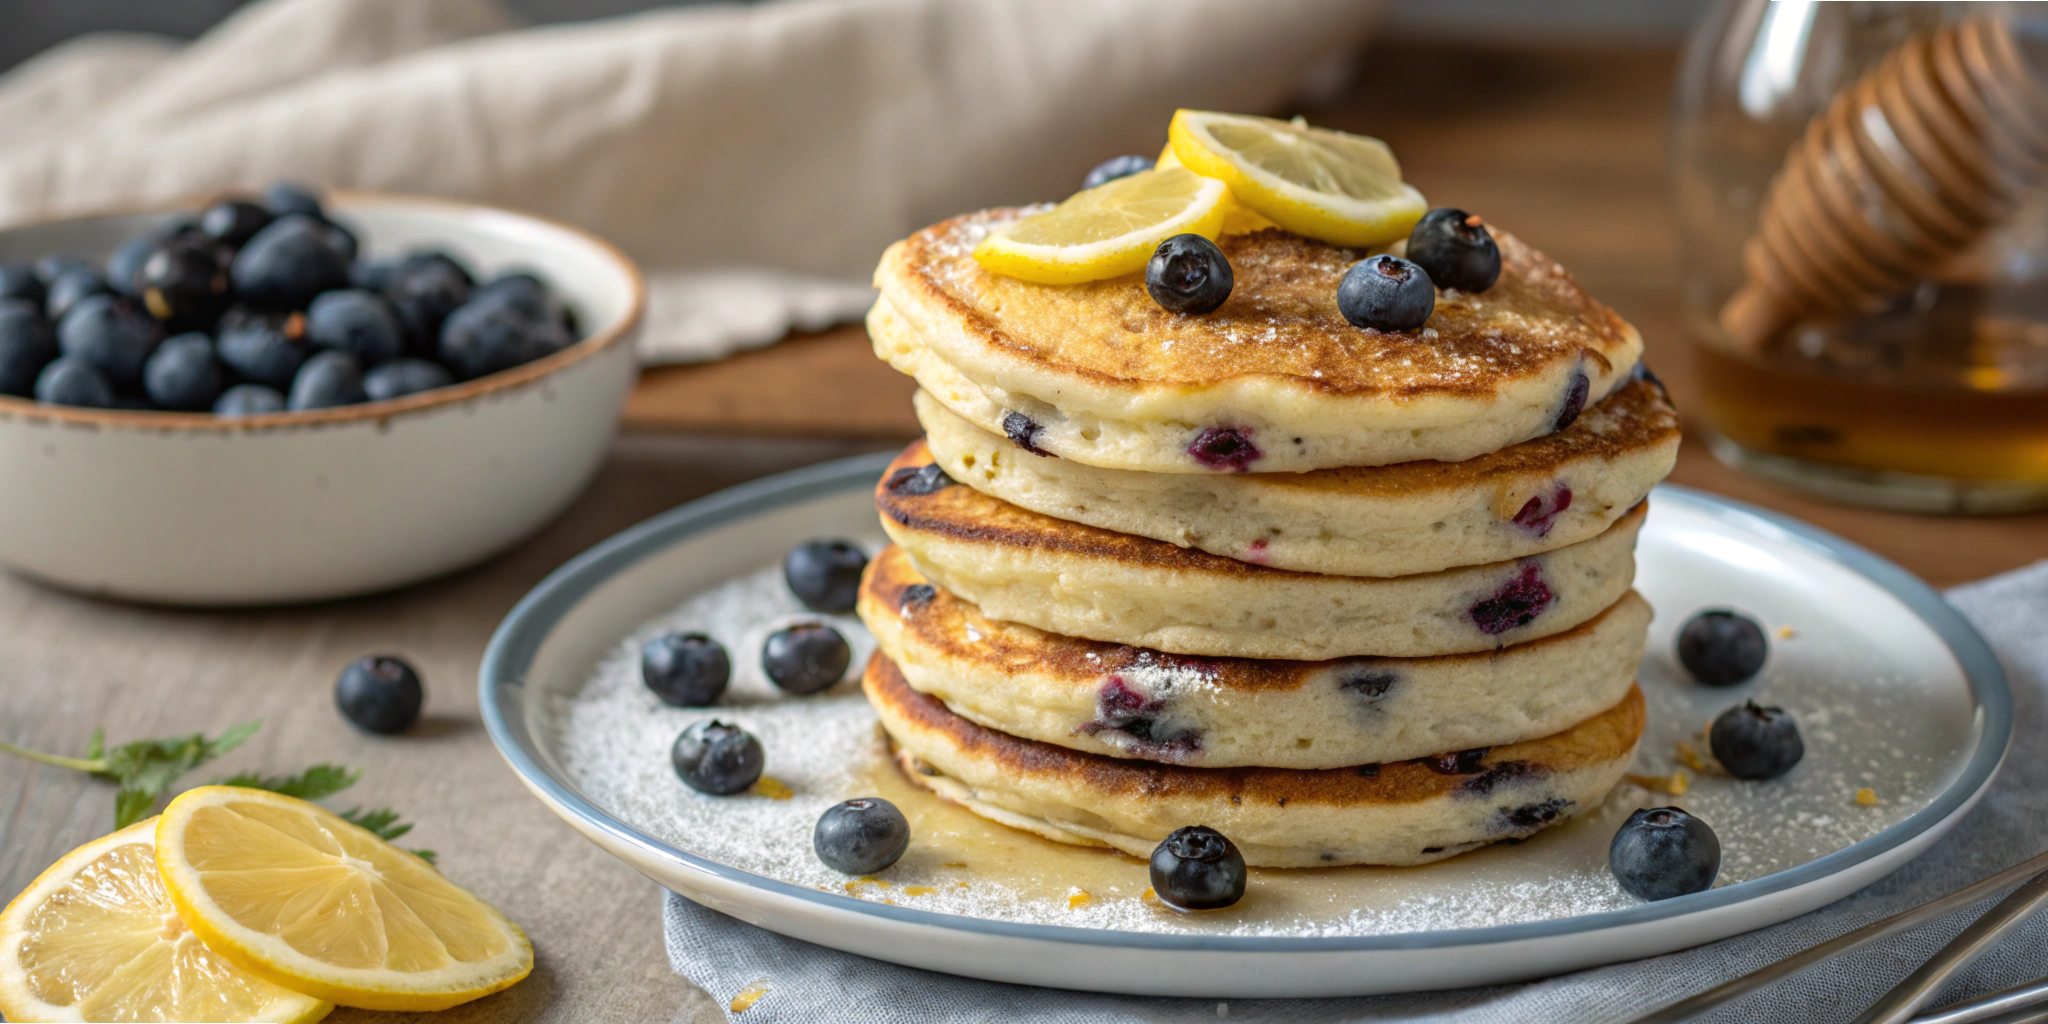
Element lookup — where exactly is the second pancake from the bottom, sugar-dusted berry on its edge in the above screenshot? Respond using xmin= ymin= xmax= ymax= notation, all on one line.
xmin=860 ymin=547 xmax=1651 ymax=768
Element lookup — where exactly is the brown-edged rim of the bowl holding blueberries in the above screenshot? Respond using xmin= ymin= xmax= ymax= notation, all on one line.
xmin=0 ymin=188 xmax=647 ymax=432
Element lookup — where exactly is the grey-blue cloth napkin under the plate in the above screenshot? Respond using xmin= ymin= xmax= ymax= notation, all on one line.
xmin=666 ymin=561 xmax=2048 ymax=1024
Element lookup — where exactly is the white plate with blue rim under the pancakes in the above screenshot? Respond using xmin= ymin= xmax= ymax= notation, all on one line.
xmin=481 ymin=455 xmax=2011 ymax=997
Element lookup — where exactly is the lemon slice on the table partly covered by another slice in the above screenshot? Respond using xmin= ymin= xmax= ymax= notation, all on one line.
xmin=0 ymin=817 xmax=334 ymax=1024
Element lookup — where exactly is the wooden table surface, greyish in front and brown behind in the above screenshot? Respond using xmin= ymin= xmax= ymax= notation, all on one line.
xmin=0 ymin=36 xmax=2048 ymax=1024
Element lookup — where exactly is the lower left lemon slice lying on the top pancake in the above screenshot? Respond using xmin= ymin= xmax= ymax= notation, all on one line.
xmin=975 ymin=168 xmax=1231 ymax=285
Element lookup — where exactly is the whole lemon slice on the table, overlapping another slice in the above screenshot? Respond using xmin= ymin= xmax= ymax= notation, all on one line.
xmin=156 ymin=786 xmax=532 ymax=1010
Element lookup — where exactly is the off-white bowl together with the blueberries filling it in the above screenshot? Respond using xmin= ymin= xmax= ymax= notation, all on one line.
xmin=0 ymin=182 xmax=645 ymax=606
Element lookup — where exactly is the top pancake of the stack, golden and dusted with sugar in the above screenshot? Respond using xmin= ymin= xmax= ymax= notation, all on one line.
xmin=868 ymin=209 xmax=1642 ymax=473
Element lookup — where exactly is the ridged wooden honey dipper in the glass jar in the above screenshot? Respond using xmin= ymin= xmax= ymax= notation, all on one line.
xmin=1720 ymin=14 xmax=2048 ymax=352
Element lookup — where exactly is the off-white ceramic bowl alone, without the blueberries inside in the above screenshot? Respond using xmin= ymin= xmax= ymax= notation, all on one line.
xmin=0 ymin=193 xmax=645 ymax=606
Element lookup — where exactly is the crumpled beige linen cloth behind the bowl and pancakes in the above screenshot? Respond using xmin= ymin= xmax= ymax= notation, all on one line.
xmin=0 ymin=0 xmax=1380 ymax=362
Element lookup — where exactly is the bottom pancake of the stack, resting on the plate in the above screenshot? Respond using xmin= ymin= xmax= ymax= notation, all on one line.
xmin=860 ymin=653 xmax=1642 ymax=868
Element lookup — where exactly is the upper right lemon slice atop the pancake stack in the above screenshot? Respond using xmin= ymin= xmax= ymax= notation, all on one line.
xmin=1167 ymin=111 xmax=1430 ymax=248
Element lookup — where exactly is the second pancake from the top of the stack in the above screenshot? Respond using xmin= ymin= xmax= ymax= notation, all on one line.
xmin=915 ymin=381 xmax=1679 ymax=575
